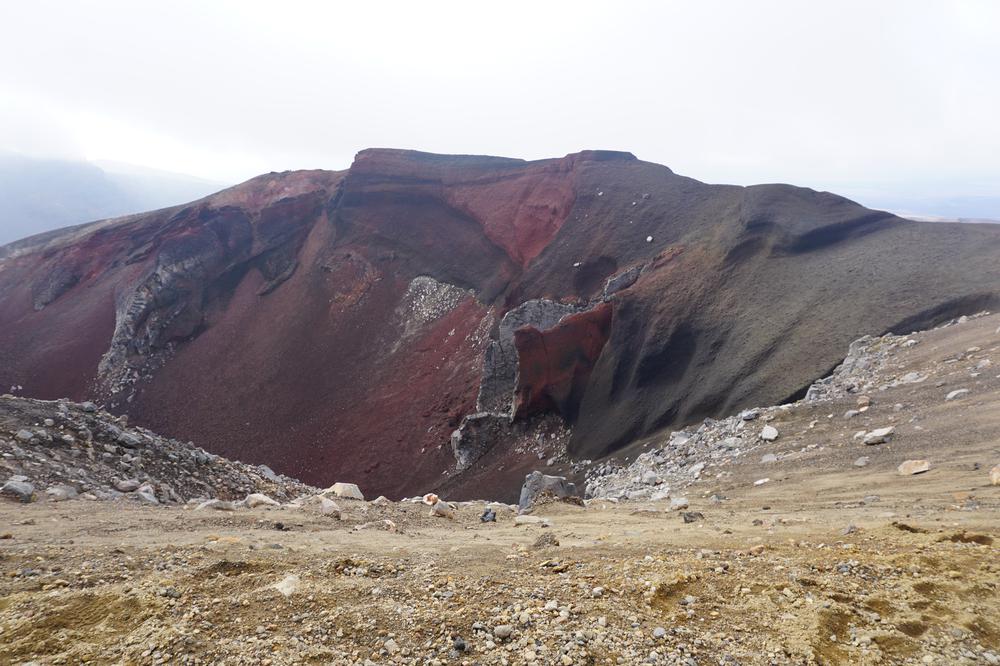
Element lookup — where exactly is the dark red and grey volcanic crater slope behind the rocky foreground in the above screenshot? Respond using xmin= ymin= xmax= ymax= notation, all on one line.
xmin=0 ymin=150 xmax=1000 ymax=498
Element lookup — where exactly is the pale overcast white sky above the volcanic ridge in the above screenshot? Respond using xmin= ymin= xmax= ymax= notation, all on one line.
xmin=0 ymin=0 xmax=1000 ymax=211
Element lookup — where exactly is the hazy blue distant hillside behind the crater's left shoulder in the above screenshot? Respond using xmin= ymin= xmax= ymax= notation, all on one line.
xmin=0 ymin=153 xmax=225 ymax=245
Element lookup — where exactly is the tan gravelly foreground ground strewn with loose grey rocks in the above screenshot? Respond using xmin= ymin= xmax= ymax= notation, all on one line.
xmin=0 ymin=315 xmax=1000 ymax=665
